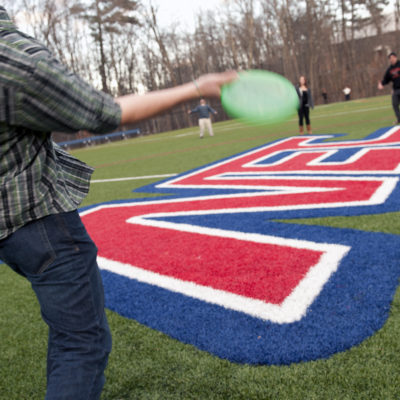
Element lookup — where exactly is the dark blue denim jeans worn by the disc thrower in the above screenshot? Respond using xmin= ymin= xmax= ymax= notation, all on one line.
xmin=0 ymin=211 xmax=111 ymax=400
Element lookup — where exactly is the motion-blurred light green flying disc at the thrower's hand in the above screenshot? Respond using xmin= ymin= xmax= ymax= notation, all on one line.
xmin=221 ymin=70 xmax=299 ymax=125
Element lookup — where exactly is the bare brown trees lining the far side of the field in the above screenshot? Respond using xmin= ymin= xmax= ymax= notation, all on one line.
xmin=3 ymin=0 xmax=400 ymax=139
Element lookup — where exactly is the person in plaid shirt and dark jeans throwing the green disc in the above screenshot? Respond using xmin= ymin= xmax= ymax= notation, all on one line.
xmin=0 ymin=6 xmax=236 ymax=400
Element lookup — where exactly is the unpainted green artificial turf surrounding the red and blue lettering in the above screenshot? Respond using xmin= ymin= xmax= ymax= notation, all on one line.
xmin=0 ymin=96 xmax=400 ymax=400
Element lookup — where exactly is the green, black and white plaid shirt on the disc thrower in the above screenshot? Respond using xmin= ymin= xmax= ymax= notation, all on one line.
xmin=0 ymin=6 xmax=121 ymax=239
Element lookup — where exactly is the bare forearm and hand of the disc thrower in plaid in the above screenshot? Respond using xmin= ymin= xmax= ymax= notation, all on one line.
xmin=115 ymin=71 xmax=237 ymax=124
